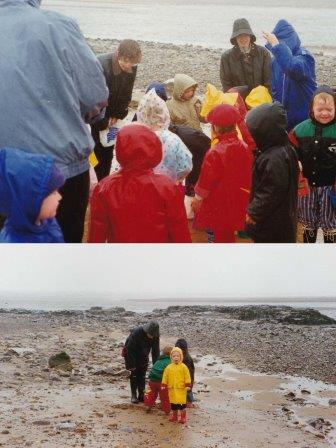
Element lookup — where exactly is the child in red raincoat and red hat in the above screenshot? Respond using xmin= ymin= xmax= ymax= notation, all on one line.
xmin=193 ymin=104 xmax=252 ymax=243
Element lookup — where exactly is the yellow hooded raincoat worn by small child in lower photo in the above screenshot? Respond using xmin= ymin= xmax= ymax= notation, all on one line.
xmin=162 ymin=347 xmax=191 ymax=404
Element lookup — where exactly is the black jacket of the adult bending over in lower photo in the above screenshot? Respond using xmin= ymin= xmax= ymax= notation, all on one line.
xmin=124 ymin=327 xmax=160 ymax=369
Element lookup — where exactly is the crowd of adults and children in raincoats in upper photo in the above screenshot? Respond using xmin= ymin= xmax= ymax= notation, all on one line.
xmin=0 ymin=0 xmax=336 ymax=243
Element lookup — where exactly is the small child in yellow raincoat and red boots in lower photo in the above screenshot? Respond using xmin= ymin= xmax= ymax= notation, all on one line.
xmin=162 ymin=347 xmax=191 ymax=423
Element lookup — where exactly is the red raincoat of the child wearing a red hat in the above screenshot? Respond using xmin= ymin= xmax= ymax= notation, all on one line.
xmin=194 ymin=131 xmax=252 ymax=242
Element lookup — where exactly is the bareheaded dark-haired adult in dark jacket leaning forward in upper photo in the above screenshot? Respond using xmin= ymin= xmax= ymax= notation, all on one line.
xmin=91 ymin=39 xmax=141 ymax=181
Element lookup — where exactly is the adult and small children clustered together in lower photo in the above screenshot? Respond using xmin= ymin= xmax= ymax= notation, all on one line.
xmin=122 ymin=321 xmax=195 ymax=423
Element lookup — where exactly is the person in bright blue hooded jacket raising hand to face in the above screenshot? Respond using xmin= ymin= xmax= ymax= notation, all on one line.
xmin=264 ymin=20 xmax=316 ymax=129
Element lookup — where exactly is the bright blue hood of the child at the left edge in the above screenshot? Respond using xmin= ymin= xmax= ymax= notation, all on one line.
xmin=0 ymin=148 xmax=54 ymax=233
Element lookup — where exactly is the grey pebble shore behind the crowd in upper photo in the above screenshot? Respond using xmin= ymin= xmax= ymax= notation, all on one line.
xmin=86 ymin=38 xmax=336 ymax=94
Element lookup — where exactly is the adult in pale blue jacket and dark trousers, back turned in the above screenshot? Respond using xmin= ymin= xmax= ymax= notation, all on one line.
xmin=0 ymin=0 xmax=108 ymax=242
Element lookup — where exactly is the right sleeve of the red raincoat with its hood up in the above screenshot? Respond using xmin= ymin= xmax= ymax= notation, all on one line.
xmin=166 ymin=185 xmax=191 ymax=243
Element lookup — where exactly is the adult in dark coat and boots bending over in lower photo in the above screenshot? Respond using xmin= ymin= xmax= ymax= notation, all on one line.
xmin=124 ymin=322 xmax=160 ymax=403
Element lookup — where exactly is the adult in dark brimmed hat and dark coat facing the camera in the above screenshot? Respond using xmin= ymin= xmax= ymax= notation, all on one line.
xmin=220 ymin=19 xmax=271 ymax=98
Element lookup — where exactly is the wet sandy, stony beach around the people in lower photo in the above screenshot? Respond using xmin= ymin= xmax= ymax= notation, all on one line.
xmin=0 ymin=306 xmax=336 ymax=448
